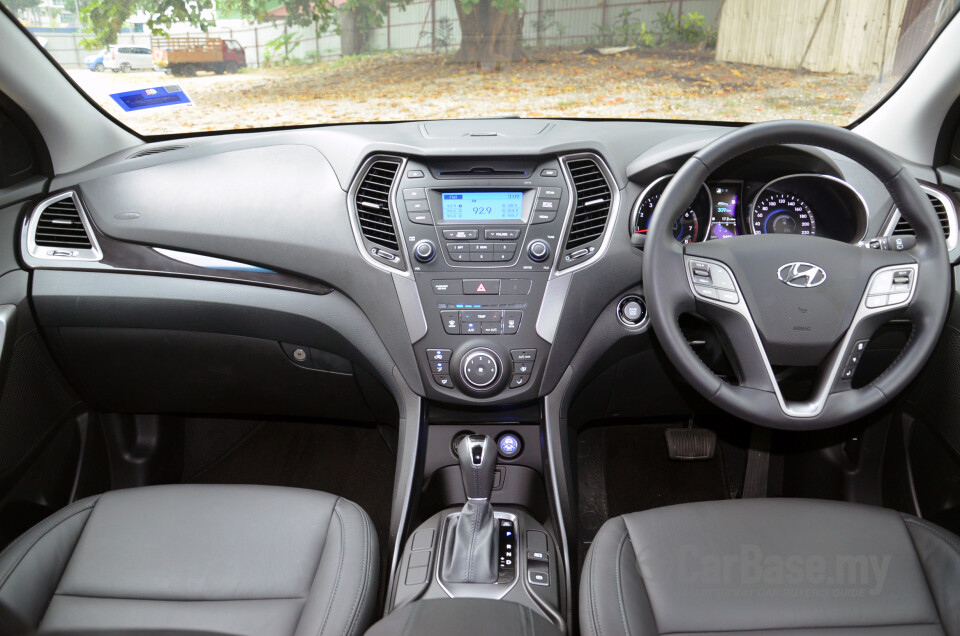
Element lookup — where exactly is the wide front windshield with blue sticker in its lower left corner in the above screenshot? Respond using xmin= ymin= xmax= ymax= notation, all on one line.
xmin=7 ymin=0 xmax=960 ymax=135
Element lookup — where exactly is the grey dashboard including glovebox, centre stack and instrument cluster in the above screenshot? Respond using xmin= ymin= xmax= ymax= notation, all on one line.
xmin=11 ymin=120 xmax=958 ymax=417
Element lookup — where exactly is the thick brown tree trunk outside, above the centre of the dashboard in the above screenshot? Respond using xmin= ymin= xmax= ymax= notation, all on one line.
xmin=454 ymin=0 xmax=523 ymax=63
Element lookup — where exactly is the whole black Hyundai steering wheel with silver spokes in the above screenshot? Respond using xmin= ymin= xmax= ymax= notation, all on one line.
xmin=642 ymin=121 xmax=951 ymax=430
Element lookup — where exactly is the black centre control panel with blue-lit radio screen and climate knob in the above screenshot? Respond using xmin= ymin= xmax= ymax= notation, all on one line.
xmin=395 ymin=158 xmax=572 ymax=401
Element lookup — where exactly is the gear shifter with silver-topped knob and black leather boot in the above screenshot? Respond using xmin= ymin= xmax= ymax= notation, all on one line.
xmin=442 ymin=435 xmax=497 ymax=583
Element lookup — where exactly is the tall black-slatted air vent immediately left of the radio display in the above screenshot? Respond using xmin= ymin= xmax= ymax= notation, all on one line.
xmin=353 ymin=157 xmax=403 ymax=268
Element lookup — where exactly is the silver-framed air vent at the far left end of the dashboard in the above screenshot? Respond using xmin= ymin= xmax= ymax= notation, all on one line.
xmin=26 ymin=192 xmax=102 ymax=261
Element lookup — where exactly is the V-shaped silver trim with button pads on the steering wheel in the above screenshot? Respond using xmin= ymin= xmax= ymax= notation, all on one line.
xmin=683 ymin=255 xmax=919 ymax=418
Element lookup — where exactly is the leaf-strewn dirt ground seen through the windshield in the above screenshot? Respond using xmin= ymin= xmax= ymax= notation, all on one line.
xmin=69 ymin=49 xmax=897 ymax=135
